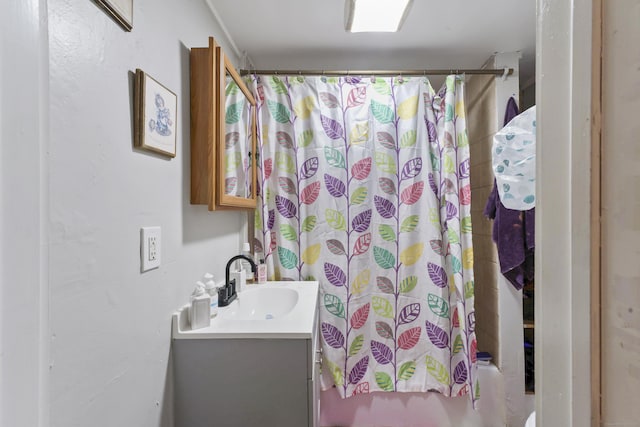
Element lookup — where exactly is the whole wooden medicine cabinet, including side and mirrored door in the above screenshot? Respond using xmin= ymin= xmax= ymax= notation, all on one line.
xmin=190 ymin=37 xmax=257 ymax=211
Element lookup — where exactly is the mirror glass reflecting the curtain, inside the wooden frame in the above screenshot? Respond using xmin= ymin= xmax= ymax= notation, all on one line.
xmin=224 ymin=71 xmax=253 ymax=198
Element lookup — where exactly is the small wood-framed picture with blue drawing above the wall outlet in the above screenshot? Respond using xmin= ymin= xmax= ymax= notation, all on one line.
xmin=133 ymin=69 xmax=178 ymax=157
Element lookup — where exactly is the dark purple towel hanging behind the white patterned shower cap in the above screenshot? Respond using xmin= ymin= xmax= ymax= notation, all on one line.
xmin=484 ymin=97 xmax=536 ymax=289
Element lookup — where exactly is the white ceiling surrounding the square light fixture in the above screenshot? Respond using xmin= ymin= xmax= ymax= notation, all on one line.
xmin=207 ymin=0 xmax=536 ymax=82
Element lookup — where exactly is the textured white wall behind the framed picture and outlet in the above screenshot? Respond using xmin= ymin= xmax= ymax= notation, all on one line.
xmin=47 ymin=0 xmax=246 ymax=427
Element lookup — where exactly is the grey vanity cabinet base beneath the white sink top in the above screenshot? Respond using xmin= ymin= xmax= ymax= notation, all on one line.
xmin=172 ymin=287 xmax=321 ymax=427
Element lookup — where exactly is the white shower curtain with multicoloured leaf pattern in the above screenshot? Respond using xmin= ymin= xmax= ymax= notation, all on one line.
xmin=253 ymin=76 xmax=479 ymax=403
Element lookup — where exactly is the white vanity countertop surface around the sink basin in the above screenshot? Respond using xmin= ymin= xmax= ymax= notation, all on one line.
xmin=172 ymin=281 xmax=319 ymax=339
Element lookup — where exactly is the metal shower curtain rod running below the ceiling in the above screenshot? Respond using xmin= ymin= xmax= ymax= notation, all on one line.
xmin=240 ymin=68 xmax=514 ymax=77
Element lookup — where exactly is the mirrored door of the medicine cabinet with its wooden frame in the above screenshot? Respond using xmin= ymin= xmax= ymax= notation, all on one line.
xmin=216 ymin=47 xmax=257 ymax=208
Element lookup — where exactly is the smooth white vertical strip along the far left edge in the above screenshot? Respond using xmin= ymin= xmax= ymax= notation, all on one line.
xmin=0 ymin=0 xmax=47 ymax=427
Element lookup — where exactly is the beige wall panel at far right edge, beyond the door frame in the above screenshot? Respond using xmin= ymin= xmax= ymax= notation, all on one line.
xmin=601 ymin=0 xmax=640 ymax=426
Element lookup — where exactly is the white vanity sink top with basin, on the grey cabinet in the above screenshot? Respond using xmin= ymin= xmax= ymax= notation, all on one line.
xmin=173 ymin=282 xmax=318 ymax=339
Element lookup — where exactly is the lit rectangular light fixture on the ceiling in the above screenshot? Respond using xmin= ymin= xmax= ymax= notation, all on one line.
xmin=344 ymin=0 xmax=413 ymax=33
